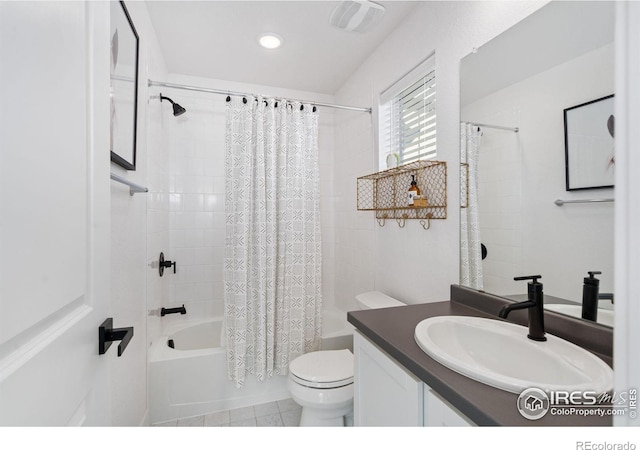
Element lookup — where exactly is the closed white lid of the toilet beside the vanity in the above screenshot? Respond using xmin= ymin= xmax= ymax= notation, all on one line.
xmin=289 ymin=349 xmax=353 ymax=387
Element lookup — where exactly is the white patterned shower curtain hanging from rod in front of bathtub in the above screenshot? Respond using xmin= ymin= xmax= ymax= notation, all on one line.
xmin=224 ymin=97 xmax=322 ymax=387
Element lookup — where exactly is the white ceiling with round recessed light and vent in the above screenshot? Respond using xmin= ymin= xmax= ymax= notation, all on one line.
xmin=147 ymin=0 xmax=419 ymax=94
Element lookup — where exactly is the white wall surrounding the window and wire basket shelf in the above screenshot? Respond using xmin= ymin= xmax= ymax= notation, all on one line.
xmin=334 ymin=2 xmax=546 ymax=309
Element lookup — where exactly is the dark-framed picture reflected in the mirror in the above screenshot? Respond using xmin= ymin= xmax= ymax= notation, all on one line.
xmin=564 ymin=95 xmax=615 ymax=191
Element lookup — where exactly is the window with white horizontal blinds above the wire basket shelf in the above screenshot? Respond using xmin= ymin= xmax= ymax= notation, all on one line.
xmin=378 ymin=55 xmax=436 ymax=170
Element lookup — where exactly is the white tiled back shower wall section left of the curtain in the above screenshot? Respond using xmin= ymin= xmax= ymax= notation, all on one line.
xmin=164 ymin=90 xmax=225 ymax=319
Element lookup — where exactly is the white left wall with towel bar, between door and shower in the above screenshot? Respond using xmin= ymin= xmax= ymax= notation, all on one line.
xmin=110 ymin=2 xmax=168 ymax=426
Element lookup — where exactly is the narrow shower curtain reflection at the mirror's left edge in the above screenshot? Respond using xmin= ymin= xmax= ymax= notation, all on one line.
xmin=460 ymin=123 xmax=483 ymax=289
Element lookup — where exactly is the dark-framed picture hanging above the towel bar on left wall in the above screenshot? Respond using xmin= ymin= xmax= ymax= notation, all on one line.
xmin=110 ymin=1 xmax=140 ymax=170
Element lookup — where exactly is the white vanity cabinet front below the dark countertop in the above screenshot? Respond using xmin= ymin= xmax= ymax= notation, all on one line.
xmin=353 ymin=331 xmax=472 ymax=427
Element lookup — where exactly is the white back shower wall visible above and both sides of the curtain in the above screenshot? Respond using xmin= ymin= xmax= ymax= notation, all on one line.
xmin=152 ymin=74 xmax=334 ymax=325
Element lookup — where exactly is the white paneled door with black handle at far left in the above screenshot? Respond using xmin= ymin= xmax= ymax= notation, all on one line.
xmin=0 ymin=1 xmax=112 ymax=426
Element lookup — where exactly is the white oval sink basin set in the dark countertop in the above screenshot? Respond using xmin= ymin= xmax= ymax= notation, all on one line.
xmin=415 ymin=316 xmax=613 ymax=394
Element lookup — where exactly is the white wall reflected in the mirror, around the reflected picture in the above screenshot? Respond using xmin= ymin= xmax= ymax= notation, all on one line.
xmin=461 ymin=44 xmax=614 ymax=302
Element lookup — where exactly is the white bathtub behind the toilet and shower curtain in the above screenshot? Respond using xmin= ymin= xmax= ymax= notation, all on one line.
xmin=149 ymin=311 xmax=353 ymax=424
